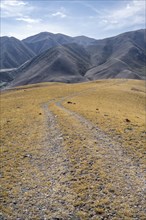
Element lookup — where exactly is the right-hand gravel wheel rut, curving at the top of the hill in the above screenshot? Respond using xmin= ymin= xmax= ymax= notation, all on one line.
xmin=53 ymin=91 xmax=145 ymax=219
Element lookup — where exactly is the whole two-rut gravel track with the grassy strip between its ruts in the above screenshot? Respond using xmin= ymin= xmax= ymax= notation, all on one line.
xmin=38 ymin=91 xmax=145 ymax=219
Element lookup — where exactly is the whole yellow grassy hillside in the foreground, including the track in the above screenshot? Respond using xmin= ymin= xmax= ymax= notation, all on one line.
xmin=0 ymin=79 xmax=146 ymax=220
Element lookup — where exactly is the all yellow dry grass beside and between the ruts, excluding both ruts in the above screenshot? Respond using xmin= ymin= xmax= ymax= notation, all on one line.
xmin=0 ymin=80 xmax=146 ymax=220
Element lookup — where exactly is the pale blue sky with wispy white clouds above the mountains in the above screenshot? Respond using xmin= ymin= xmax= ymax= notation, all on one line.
xmin=0 ymin=0 xmax=146 ymax=40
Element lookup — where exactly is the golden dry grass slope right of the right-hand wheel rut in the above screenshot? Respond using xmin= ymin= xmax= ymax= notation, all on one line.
xmin=64 ymin=80 xmax=146 ymax=162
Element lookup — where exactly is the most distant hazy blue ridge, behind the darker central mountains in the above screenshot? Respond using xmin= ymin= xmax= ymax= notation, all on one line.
xmin=22 ymin=32 xmax=95 ymax=55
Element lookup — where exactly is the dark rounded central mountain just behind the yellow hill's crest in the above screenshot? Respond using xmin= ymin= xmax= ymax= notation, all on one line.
xmin=12 ymin=44 xmax=90 ymax=86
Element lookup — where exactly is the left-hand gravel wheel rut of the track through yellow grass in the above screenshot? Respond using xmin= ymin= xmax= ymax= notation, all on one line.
xmin=40 ymin=104 xmax=74 ymax=219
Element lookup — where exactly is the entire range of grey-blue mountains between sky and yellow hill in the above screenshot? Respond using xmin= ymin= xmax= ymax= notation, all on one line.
xmin=0 ymin=30 xmax=146 ymax=86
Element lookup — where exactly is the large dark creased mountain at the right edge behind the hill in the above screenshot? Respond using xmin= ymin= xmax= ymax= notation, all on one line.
xmin=85 ymin=30 xmax=146 ymax=80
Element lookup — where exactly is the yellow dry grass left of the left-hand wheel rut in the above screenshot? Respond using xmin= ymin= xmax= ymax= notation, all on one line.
xmin=0 ymin=83 xmax=92 ymax=219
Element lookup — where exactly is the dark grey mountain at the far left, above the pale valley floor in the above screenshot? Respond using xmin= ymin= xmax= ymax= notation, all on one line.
xmin=0 ymin=37 xmax=35 ymax=69
